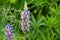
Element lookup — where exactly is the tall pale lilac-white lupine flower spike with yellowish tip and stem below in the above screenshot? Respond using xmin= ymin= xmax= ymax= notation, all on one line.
xmin=21 ymin=2 xmax=30 ymax=40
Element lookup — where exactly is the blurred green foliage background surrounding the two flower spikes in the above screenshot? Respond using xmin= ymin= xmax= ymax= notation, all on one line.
xmin=0 ymin=0 xmax=60 ymax=40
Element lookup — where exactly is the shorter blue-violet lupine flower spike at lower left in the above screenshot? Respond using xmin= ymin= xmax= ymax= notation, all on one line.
xmin=5 ymin=24 xmax=13 ymax=40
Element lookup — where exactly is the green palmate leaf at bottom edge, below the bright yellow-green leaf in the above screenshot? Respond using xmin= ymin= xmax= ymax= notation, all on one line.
xmin=37 ymin=29 xmax=56 ymax=40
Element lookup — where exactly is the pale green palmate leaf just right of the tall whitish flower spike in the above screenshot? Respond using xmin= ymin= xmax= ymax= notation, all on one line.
xmin=30 ymin=14 xmax=44 ymax=28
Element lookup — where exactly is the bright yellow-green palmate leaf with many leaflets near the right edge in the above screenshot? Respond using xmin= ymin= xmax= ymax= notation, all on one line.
xmin=44 ymin=15 xmax=59 ymax=27
